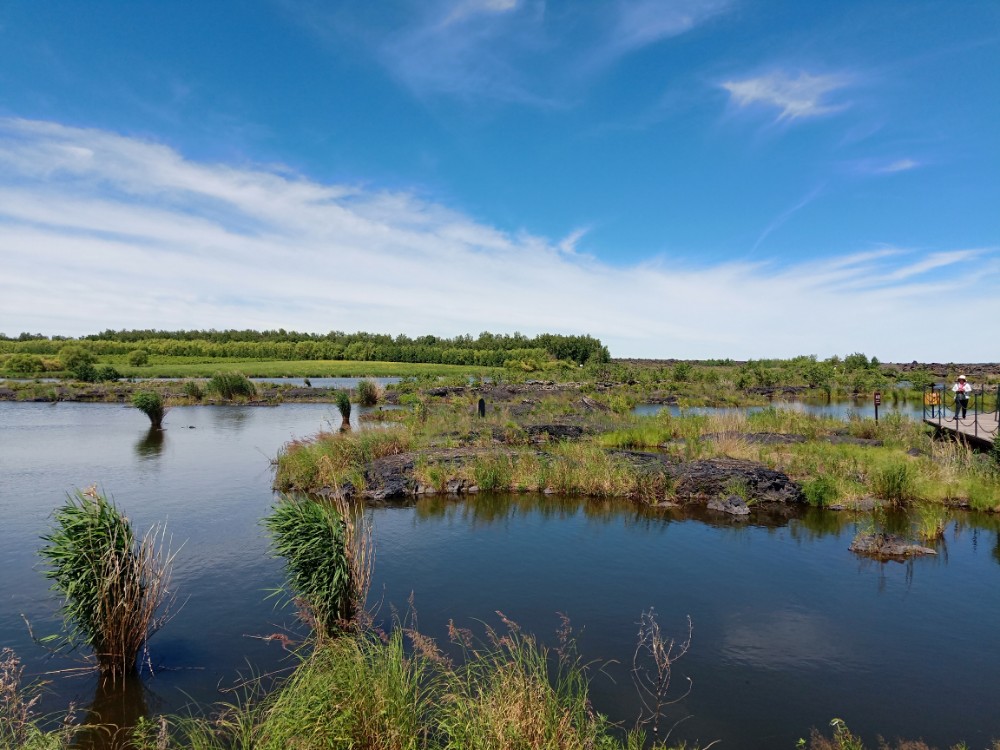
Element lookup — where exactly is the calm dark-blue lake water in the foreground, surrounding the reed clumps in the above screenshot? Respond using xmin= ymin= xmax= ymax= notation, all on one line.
xmin=0 ymin=403 xmax=1000 ymax=749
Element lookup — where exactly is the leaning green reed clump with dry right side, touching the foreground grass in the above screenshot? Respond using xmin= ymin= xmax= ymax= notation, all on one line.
xmin=264 ymin=496 xmax=373 ymax=639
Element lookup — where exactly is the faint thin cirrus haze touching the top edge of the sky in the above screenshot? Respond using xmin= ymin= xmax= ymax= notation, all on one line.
xmin=288 ymin=0 xmax=734 ymax=107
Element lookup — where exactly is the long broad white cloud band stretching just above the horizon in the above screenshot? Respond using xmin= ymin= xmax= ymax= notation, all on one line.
xmin=0 ymin=120 xmax=1000 ymax=361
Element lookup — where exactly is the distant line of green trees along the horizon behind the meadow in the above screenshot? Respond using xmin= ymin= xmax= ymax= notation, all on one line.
xmin=0 ymin=328 xmax=611 ymax=367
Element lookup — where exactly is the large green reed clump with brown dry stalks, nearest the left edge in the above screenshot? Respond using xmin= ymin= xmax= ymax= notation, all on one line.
xmin=41 ymin=487 xmax=172 ymax=677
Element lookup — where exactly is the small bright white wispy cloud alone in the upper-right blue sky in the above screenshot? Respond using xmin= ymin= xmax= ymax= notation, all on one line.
xmin=720 ymin=70 xmax=849 ymax=120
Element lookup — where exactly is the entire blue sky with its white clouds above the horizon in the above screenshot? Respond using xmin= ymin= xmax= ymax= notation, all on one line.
xmin=0 ymin=0 xmax=1000 ymax=361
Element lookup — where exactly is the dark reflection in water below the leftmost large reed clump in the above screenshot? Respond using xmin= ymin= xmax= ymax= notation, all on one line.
xmin=73 ymin=674 xmax=149 ymax=750
